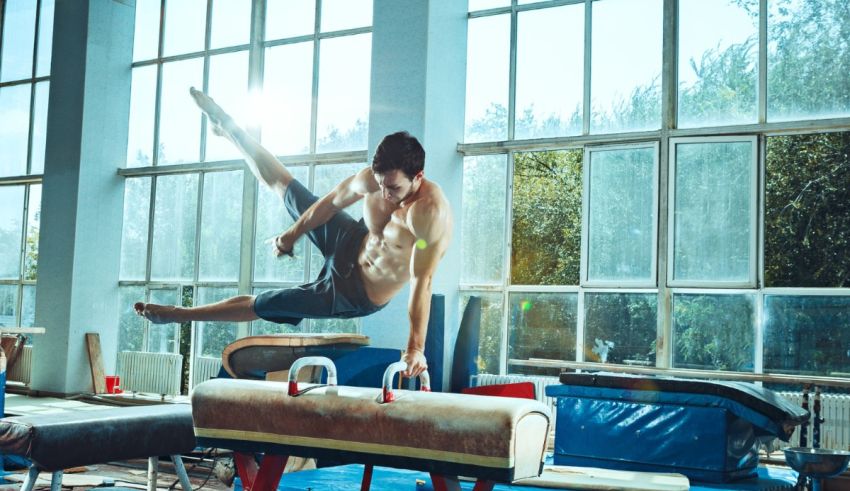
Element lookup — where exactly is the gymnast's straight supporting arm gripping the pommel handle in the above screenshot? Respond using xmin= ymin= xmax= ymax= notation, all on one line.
xmin=404 ymin=203 xmax=451 ymax=377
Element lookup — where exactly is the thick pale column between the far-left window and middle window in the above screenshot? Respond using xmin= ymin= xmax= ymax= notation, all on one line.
xmin=31 ymin=0 xmax=135 ymax=393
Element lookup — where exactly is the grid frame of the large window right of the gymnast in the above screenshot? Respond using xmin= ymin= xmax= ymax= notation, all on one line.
xmin=457 ymin=0 xmax=850 ymax=379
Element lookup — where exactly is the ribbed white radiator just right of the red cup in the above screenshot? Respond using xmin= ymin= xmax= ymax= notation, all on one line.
xmin=117 ymin=351 xmax=183 ymax=396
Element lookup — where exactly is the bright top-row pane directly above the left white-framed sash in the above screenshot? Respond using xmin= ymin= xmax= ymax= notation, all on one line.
xmin=590 ymin=0 xmax=664 ymax=133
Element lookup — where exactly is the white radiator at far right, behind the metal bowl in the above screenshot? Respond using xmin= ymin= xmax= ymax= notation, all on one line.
xmin=779 ymin=392 xmax=850 ymax=450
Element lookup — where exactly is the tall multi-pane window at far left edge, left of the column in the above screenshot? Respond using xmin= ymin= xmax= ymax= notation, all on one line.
xmin=0 ymin=0 xmax=53 ymax=326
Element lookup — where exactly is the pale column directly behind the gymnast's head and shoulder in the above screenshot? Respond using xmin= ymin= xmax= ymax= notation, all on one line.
xmin=363 ymin=0 xmax=467 ymax=390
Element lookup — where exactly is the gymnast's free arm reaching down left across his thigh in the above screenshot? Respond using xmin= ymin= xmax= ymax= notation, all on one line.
xmin=274 ymin=167 xmax=378 ymax=255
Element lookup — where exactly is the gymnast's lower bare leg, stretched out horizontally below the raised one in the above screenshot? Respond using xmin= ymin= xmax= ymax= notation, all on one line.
xmin=133 ymin=295 xmax=259 ymax=324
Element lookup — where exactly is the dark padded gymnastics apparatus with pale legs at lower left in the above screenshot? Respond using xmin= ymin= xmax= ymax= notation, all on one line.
xmin=0 ymin=404 xmax=195 ymax=491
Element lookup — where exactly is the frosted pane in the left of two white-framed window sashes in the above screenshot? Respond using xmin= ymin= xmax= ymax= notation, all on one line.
xmin=587 ymin=148 xmax=657 ymax=283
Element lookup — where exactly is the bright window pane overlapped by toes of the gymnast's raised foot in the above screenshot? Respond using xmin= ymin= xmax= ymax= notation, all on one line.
xmin=158 ymin=59 xmax=204 ymax=164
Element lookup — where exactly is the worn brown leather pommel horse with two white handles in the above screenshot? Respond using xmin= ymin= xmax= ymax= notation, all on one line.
xmin=192 ymin=357 xmax=550 ymax=491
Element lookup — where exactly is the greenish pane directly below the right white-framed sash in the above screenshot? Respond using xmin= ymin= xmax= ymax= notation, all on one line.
xmin=673 ymin=294 xmax=756 ymax=372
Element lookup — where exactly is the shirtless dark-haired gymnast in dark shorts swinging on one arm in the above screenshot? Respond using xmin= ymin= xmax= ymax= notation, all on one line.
xmin=134 ymin=88 xmax=452 ymax=376
